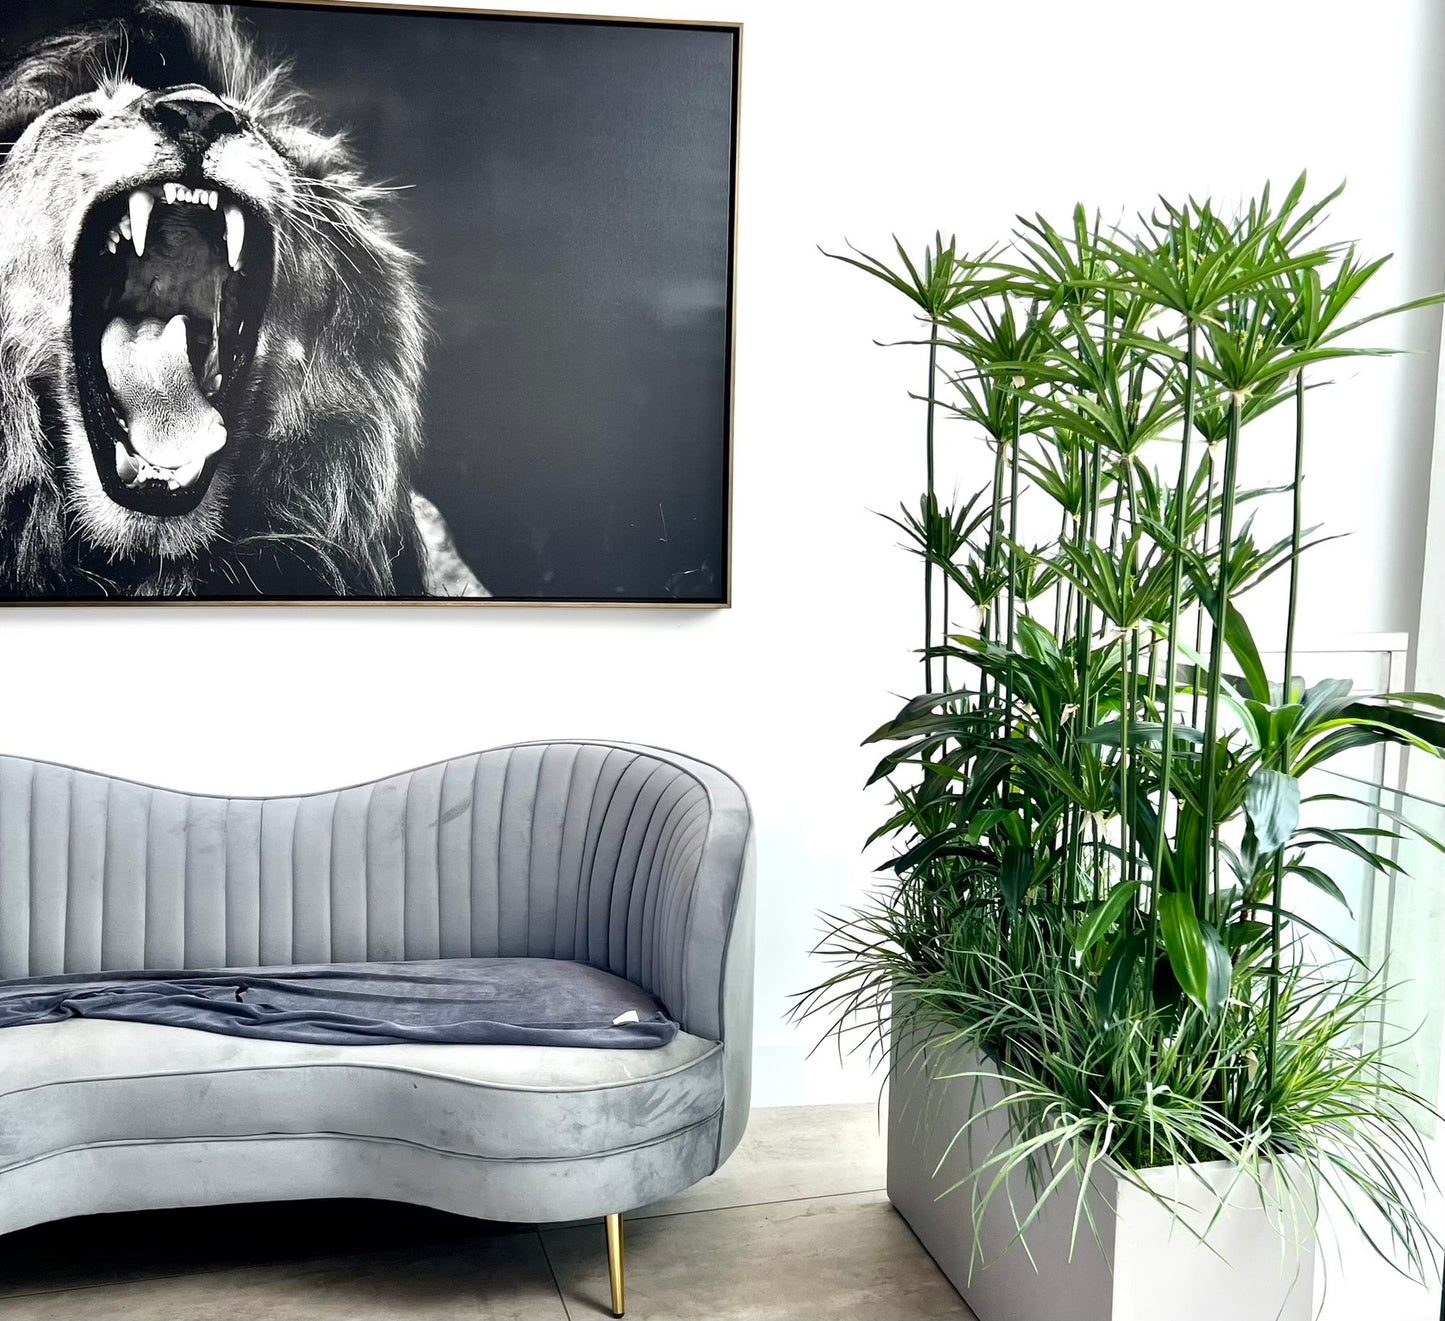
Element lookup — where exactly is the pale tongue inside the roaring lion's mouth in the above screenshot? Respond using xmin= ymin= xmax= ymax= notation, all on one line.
xmin=100 ymin=317 xmax=225 ymax=486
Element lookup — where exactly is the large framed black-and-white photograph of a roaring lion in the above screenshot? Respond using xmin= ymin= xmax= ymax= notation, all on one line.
xmin=0 ymin=0 xmax=741 ymax=606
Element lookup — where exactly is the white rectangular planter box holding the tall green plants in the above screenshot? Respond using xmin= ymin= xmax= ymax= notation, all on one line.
xmin=889 ymin=1017 xmax=1315 ymax=1321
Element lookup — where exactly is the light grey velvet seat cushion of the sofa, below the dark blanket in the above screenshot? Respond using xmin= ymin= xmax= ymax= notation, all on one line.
xmin=0 ymin=1019 xmax=723 ymax=1172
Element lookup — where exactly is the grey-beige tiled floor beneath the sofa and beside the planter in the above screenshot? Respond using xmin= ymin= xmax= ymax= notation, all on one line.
xmin=0 ymin=1106 xmax=972 ymax=1321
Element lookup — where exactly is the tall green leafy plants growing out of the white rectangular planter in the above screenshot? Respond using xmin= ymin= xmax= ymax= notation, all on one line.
xmin=795 ymin=178 xmax=1445 ymax=1294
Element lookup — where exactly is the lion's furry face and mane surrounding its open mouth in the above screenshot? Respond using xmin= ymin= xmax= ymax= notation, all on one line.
xmin=0 ymin=0 xmax=481 ymax=598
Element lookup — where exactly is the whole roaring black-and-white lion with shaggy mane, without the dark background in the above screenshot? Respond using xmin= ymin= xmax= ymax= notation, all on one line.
xmin=0 ymin=0 xmax=486 ymax=598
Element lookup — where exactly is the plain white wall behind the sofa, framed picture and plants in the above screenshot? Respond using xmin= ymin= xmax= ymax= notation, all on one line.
xmin=0 ymin=0 xmax=1445 ymax=1103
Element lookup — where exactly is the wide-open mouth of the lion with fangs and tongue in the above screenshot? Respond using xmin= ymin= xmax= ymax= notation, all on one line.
xmin=71 ymin=182 xmax=272 ymax=516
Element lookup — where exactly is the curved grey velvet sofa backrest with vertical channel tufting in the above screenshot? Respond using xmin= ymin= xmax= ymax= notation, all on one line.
xmin=0 ymin=743 xmax=750 ymax=1038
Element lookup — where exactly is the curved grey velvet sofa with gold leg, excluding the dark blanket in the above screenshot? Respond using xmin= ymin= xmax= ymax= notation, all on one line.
xmin=0 ymin=741 xmax=753 ymax=1314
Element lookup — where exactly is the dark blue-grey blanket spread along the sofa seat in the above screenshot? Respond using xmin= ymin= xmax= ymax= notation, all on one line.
xmin=0 ymin=958 xmax=678 ymax=1049
